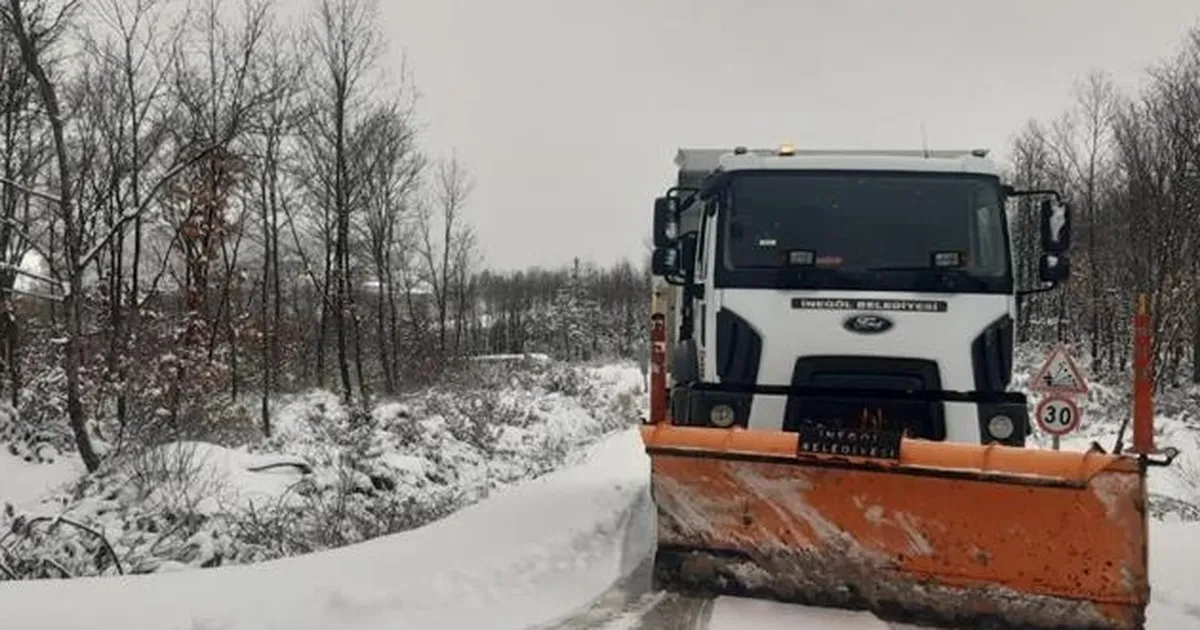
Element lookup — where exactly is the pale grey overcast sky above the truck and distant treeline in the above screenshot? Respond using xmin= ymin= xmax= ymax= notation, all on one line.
xmin=380 ymin=0 xmax=1200 ymax=269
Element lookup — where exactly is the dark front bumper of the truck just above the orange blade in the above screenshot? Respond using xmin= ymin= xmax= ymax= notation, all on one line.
xmin=670 ymin=383 xmax=1032 ymax=446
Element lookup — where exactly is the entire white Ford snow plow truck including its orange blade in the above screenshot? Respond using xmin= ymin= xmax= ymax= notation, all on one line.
xmin=641 ymin=145 xmax=1176 ymax=630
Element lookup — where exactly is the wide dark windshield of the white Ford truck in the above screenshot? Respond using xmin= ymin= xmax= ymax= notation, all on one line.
xmin=718 ymin=172 xmax=1012 ymax=293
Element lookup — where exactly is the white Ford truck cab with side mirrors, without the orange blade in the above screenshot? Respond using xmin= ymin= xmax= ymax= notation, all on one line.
xmin=653 ymin=146 xmax=1070 ymax=445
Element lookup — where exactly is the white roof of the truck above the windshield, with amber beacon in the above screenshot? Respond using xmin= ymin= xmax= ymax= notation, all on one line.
xmin=676 ymin=149 xmax=1000 ymax=180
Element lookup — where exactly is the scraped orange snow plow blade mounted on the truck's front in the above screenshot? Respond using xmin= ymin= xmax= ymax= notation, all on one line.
xmin=642 ymin=424 xmax=1150 ymax=629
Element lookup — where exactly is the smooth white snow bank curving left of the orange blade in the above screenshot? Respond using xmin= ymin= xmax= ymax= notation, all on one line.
xmin=0 ymin=431 xmax=649 ymax=630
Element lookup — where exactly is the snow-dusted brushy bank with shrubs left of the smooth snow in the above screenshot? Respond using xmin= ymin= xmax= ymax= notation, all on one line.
xmin=0 ymin=364 xmax=644 ymax=577
